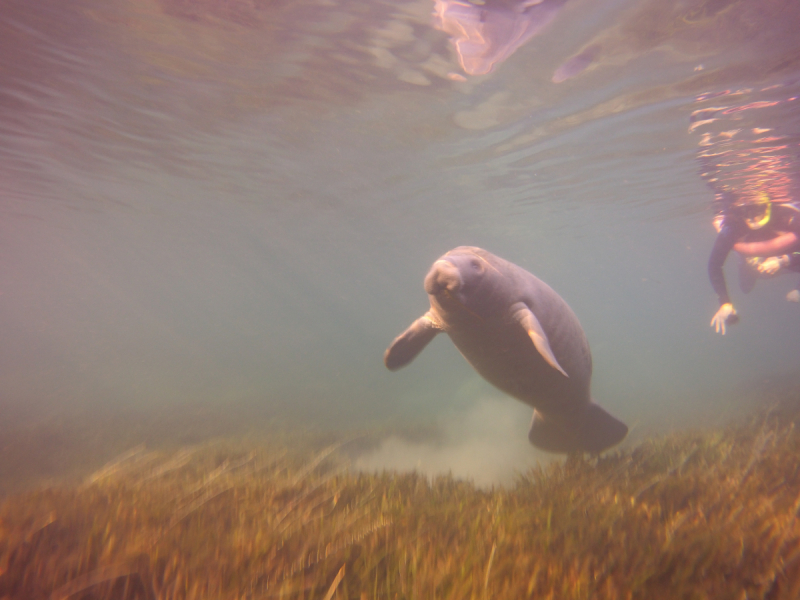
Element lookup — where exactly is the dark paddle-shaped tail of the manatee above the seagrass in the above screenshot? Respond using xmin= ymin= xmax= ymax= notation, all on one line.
xmin=528 ymin=402 xmax=628 ymax=454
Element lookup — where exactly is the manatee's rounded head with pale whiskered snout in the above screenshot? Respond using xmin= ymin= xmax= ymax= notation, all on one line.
xmin=425 ymin=246 xmax=500 ymax=316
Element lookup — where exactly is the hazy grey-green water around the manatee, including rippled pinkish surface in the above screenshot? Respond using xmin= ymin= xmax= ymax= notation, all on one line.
xmin=0 ymin=0 xmax=800 ymax=482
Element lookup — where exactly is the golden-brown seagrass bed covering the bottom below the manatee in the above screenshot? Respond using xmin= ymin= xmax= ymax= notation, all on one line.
xmin=0 ymin=404 xmax=800 ymax=600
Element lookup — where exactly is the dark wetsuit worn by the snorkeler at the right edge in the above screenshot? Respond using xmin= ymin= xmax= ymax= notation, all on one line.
xmin=708 ymin=203 xmax=800 ymax=306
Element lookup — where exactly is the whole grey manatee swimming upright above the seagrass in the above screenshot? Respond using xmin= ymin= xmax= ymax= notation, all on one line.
xmin=384 ymin=246 xmax=628 ymax=453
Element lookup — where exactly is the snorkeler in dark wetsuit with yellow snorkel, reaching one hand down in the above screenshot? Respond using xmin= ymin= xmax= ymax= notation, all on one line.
xmin=708 ymin=194 xmax=800 ymax=335
